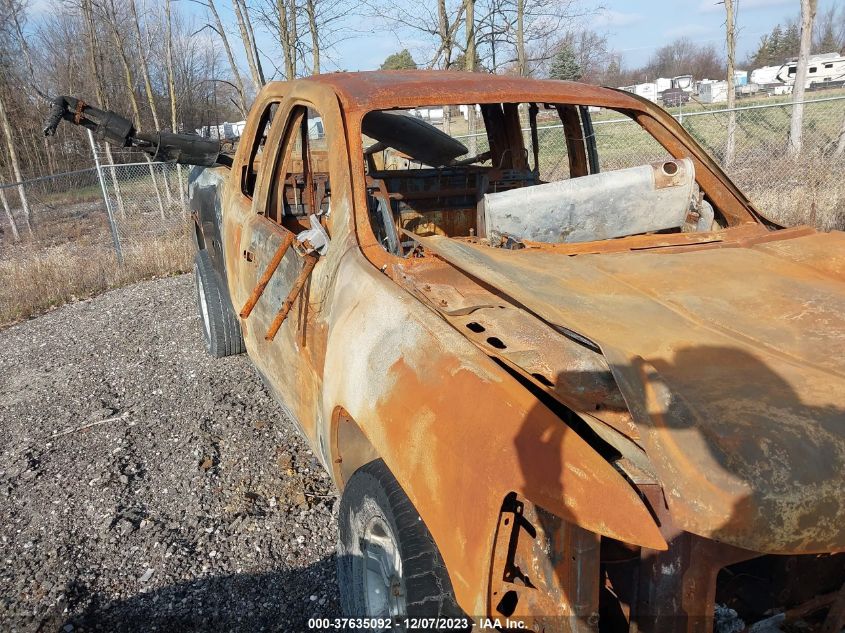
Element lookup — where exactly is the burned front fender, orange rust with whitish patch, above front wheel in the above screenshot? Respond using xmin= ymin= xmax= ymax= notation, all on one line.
xmin=322 ymin=251 xmax=666 ymax=613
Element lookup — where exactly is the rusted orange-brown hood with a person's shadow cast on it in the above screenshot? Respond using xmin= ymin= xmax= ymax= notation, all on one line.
xmin=421 ymin=233 xmax=845 ymax=553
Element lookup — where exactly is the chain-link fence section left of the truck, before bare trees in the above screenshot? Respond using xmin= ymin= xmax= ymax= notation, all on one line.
xmin=0 ymin=157 xmax=191 ymax=324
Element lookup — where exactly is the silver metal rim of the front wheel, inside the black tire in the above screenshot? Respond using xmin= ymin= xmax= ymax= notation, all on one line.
xmin=361 ymin=517 xmax=405 ymax=618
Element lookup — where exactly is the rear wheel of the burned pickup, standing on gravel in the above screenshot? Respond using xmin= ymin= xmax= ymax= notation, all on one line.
xmin=194 ymin=250 xmax=246 ymax=358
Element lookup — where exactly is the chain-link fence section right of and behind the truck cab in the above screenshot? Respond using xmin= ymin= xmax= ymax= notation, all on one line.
xmin=455 ymin=96 xmax=845 ymax=230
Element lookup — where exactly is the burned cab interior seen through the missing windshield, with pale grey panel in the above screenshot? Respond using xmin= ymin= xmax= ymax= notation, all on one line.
xmin=362 ymin=103 xmax=725 ymax=257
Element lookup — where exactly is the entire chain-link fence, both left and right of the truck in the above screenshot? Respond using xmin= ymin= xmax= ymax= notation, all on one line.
xmin=0 ymin=96 xmax=845 ymax=324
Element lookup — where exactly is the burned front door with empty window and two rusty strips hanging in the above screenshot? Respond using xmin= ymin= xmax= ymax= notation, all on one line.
xmin=237 ymin=93 xmax=351 ymax=444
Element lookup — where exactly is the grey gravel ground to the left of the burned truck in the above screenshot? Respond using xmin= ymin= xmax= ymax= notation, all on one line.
xmin=0 ymin=275 xmax=338 ymax=631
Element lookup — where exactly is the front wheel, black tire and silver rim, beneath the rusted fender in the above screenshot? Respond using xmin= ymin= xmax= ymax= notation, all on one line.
xmin=337 ymin=460 xmax=469 ymax=630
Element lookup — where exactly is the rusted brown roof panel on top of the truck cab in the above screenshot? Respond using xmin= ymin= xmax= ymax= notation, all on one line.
xmin=268 ymin=70 xmax=644 ymax=111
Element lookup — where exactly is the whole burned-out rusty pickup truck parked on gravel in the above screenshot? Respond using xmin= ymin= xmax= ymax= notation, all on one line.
xmin=47 ymin=72 xmax=845 ymax=633
